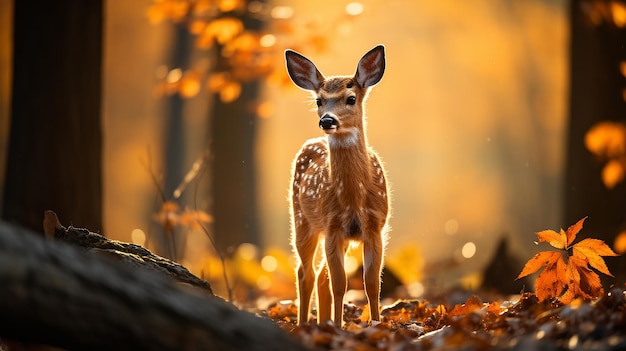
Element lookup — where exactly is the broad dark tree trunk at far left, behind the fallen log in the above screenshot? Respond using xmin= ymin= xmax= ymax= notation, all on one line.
xmin=2 ymin=0 xmax=103 ymax=231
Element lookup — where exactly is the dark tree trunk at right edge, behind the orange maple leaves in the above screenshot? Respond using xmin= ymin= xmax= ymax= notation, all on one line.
xmin=564 ymin=0 xmax=626 ymax=282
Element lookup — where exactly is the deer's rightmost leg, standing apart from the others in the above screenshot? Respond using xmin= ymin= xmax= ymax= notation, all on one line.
xmin=363 ymin=232 xmax=383 ymax=321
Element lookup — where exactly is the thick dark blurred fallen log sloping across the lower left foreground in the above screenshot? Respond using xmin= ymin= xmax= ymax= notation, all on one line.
xmin=0 ymin=222 xmax=305 ymax=350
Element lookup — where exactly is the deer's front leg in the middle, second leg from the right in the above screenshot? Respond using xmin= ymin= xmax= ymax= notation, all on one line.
xmin=325 ymin=231 xmax=348 ymax=326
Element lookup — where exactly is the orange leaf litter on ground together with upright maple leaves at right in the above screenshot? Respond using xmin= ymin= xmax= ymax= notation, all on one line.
xmin=260 ymin=217 xmax=626 ymax=351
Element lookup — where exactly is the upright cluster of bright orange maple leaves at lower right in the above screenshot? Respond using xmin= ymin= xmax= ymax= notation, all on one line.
xmin=516 ymin=217 xmax=617 ymax=304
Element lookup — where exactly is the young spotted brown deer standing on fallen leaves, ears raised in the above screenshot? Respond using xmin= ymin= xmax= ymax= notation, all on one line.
xmin=285 ymin=45 xmax=389 ymax=325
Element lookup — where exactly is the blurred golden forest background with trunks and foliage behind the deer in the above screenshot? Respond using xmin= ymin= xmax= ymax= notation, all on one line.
xmin=0 ymin=0 xmax=626 ymax=300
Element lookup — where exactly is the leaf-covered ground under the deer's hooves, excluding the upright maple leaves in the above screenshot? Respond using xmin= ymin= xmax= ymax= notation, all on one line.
xmin=259 ymin=288 xmax=626 ymax=351
